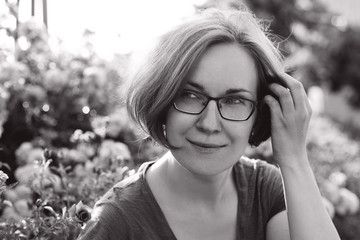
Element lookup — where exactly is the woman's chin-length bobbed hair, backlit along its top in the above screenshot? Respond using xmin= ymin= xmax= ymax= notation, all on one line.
xmin=126 ymin=9 xmax=284 ymax=148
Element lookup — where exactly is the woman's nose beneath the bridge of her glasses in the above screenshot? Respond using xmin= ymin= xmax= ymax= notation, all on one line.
xmin=196 ymin=101 xmax=221 ymax=134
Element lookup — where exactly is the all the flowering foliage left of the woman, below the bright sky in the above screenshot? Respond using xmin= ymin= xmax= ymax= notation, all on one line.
xmin=0 ymin=2 xmax=163 ymax=239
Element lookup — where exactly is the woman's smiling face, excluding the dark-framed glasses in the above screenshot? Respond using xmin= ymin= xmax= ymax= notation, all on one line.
xmin=166 ymin=44 xmax=258 ymax=175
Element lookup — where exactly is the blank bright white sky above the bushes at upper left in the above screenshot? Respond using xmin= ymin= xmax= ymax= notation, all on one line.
xmin=19 ymin=0 xmax=204 ymax=56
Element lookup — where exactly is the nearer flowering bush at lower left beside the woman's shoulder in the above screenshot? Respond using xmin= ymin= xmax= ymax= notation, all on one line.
xmin=0 ymin=127 xmax=163 ymax=239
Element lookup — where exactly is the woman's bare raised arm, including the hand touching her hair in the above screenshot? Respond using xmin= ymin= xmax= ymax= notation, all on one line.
xmin=265 ymin=74 xmax=340 ymax=240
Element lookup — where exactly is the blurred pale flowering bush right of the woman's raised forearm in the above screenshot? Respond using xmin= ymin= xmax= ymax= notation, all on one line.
xmin=308 ymin=117 xmax=360 ymax=240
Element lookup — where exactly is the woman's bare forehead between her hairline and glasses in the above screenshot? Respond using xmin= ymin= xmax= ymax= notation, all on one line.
xmin=187 ymin=44 xmax=258 ymax=95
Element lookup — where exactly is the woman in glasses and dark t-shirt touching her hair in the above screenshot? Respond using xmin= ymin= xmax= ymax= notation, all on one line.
xmin=80 ymin=7 xmax=339 ymax=240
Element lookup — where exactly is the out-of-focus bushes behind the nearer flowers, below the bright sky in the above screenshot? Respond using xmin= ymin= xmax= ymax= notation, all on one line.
xmin=0 ymin=8 xmax=126 ymax=181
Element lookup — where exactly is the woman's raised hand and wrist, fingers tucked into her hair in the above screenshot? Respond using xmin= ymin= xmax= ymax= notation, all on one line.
xmin=265 ymin=73 xmax=312 ymax=167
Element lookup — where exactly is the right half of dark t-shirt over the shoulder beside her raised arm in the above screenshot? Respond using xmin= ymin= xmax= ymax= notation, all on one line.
xmin=234 ymin=157 xmax=286 ymax=232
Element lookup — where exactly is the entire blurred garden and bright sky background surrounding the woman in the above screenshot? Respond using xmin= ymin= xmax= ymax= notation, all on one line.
xmin=0 ymin=0 xmax=360 ymax=240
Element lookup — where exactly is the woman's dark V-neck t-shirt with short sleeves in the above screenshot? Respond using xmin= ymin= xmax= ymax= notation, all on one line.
xmin=78 ymin=157 xmax=285 ymax=240
